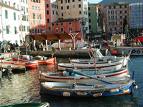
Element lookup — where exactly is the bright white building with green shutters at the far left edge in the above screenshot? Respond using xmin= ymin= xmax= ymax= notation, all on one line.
xmin=0 ymin=0 xmax=20 ymax=43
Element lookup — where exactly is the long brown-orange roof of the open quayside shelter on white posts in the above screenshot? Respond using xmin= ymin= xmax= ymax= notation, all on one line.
xmin=29 ymin=33 xmax=79 ymax=41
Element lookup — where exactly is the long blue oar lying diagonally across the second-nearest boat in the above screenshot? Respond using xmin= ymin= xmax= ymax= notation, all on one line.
xmin=66 ymin=69 xmax=113 ymax=84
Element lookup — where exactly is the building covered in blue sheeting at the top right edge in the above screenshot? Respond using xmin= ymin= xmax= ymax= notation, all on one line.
xmin=129 ymin=3 xmax=143 ymax=29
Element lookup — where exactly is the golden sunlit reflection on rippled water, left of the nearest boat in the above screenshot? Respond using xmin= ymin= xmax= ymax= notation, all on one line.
xmin=0 ymin=72 xmax=40 ymax=105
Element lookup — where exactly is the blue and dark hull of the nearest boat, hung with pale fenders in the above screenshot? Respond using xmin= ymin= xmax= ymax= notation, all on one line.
xmin=41 ymin=82 xmax=132 ymax=97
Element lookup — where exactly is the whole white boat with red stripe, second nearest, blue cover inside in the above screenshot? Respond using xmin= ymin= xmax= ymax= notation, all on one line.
xmin=39 ymin=69 xmax=129 ymax=83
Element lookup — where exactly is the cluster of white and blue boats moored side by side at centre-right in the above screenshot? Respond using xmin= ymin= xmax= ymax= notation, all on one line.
xmin=39 ymin=49 xmax=136 ymax=97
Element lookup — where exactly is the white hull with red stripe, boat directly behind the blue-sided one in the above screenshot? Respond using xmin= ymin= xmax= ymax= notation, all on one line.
xmin=39 ymin=69 xmax=128 ymax=83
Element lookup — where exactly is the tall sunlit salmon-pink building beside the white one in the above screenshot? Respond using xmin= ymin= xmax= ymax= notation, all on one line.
xmin=28 ymin=0 xmax=46 ymax=34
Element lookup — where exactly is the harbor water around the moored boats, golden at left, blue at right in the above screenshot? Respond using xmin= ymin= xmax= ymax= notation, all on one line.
xmin=0 ymin=57 xmax=143 ymax=107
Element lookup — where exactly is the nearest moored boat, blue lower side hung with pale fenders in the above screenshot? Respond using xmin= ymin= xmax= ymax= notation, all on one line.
xmin=40 ymin=80 xmax=134 ymax=97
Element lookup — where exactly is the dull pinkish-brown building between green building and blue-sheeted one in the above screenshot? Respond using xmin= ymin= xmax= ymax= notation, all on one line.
xmin=100 ymin=3 xmax=129 ymax=36
